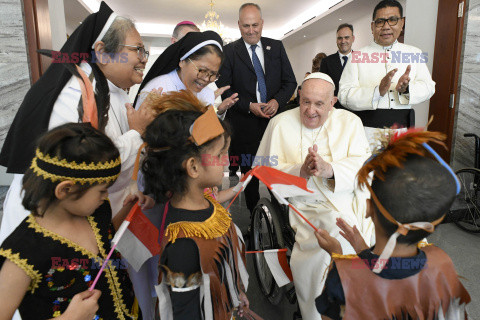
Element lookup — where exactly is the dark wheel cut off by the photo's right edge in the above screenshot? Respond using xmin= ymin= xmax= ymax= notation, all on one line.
xmin=450 ymin=168 xmax=480 ymax=233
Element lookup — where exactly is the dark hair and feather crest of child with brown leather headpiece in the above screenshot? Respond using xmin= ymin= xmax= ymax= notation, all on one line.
xmin=142 ymin=91 xmax=230 ymax=202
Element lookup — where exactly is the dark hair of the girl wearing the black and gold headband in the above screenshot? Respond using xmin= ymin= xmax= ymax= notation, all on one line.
xmin=22 ymin=123 xmax=119 ymax=216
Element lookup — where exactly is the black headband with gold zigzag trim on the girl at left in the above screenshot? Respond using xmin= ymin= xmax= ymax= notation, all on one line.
xmin=30 ymin=148 xmax=121 ymax=185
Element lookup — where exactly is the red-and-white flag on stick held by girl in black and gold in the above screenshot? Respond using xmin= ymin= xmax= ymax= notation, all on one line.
xmin=112 ymin=203 xmax=160 ymax=271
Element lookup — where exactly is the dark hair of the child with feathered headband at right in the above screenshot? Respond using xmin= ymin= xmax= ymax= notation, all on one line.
xmin=372 ymin=154 xmax=456 ymax=244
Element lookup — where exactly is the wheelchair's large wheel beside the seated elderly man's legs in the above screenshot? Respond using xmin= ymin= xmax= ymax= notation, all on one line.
xmin=251 ymin=198 xmax=284 ymax=305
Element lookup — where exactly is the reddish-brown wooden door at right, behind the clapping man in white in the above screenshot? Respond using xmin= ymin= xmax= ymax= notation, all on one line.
xmin=428 ymin=0 xmax=466 ymax=162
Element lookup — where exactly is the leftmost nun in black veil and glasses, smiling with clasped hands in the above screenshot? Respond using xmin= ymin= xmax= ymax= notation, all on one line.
xmin=0 ymin=2 xmax=153 ymax=248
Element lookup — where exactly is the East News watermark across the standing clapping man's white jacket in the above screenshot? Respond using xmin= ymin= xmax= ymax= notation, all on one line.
xmin=352 ymin=51 xmax=428 ymax=63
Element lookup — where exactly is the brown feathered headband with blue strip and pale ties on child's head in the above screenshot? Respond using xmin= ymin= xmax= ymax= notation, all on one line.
xmin=358 ymin=129 xmax=461 ymax=273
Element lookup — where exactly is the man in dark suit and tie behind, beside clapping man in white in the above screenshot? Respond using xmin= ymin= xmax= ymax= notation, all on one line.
xmin=320 ymin=23 xmax=355 ymax=109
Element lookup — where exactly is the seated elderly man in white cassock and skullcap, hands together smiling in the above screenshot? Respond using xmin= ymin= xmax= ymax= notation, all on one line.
xmin=257 ymin=72 xmax=373 ymax=320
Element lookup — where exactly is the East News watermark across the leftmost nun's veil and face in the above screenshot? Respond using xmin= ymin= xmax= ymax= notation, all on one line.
xmin=52 ymin=51 xmax=128 ymax=64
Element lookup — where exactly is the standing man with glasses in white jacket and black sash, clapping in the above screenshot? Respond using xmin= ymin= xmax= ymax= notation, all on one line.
xmin=338 ymin=1 xmax=435 ymax=143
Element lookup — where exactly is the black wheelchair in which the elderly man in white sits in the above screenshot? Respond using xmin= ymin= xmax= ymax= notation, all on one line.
xmin=250 ymin=191 xmax=297 ymax=305
